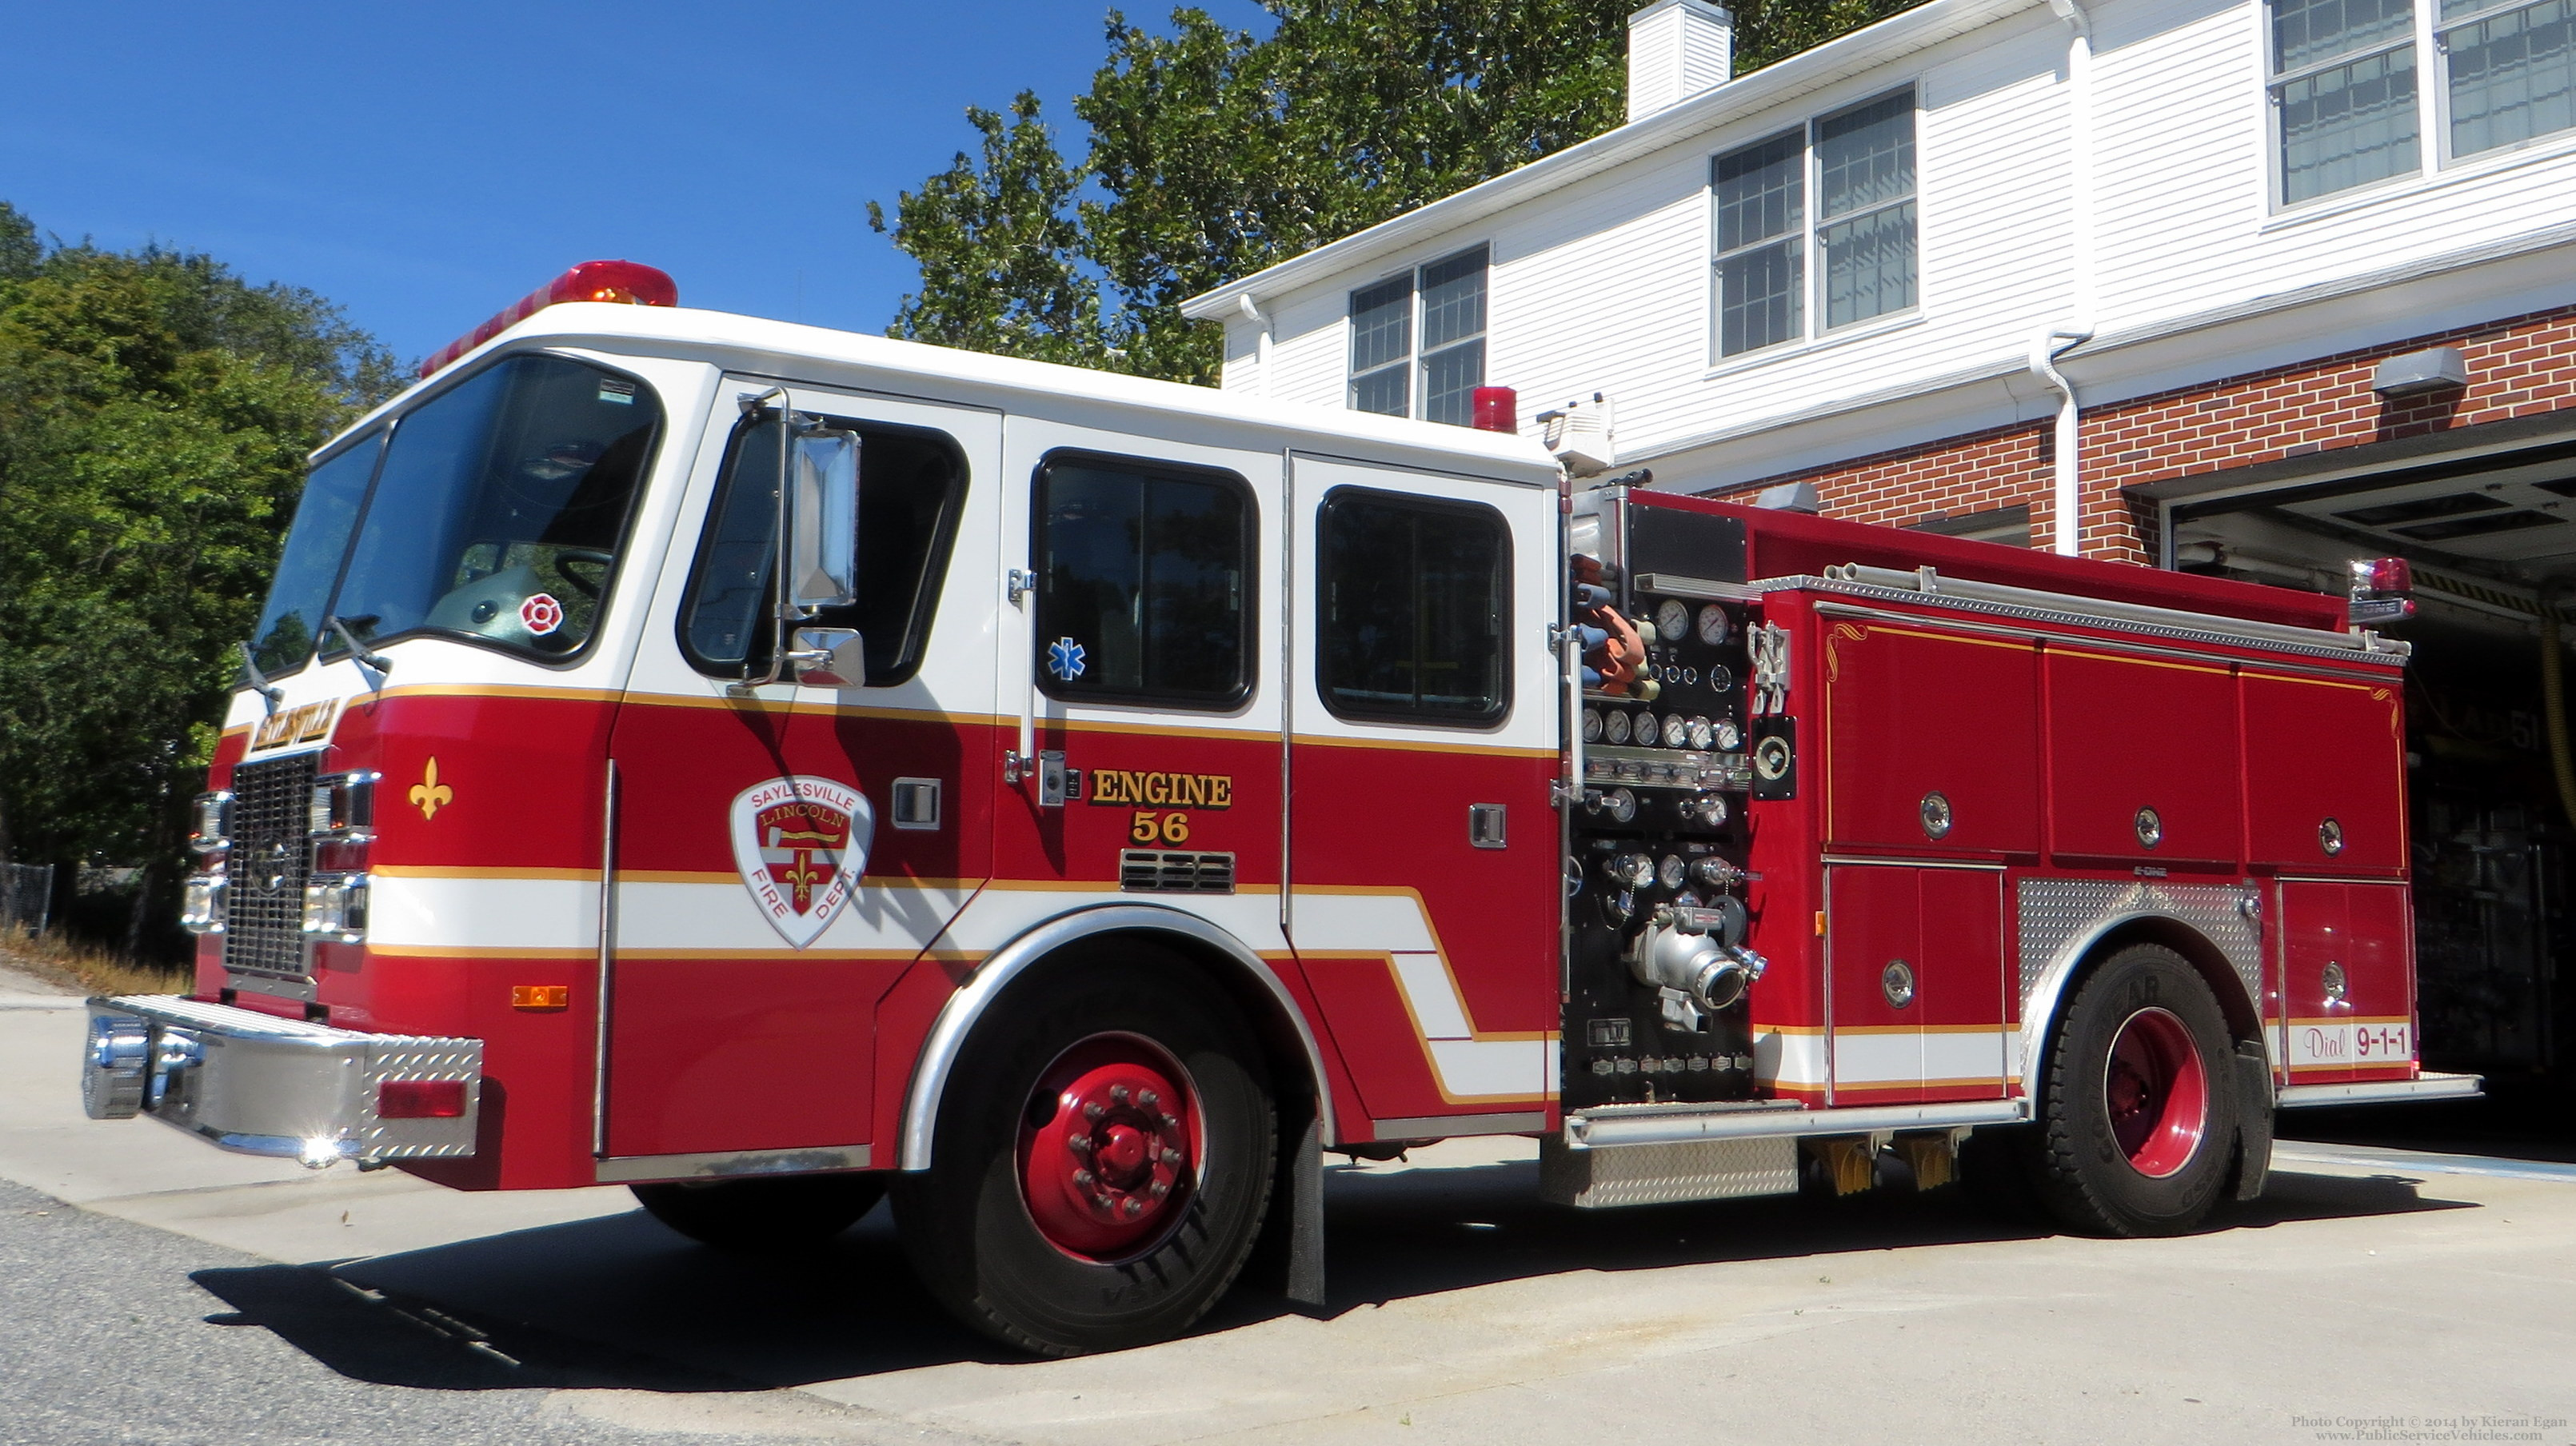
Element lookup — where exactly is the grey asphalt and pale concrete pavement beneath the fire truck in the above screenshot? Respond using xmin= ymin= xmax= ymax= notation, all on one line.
xmin=0 ymin=948 xmax=2576 ymax=1446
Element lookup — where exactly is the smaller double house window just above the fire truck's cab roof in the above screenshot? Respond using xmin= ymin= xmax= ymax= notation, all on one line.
xmin=1350 ymin=245 xmax=1489 ymax=428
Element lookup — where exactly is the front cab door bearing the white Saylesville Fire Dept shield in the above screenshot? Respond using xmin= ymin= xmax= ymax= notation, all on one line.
xmin=600 ymin=377 xmax=1002 ymax=1164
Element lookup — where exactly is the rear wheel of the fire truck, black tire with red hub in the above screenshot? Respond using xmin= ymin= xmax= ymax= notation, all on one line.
xmin=2032 ymin=944 xmax=2236 ymax=1235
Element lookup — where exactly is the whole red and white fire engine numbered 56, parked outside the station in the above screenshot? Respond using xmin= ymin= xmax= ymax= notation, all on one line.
xmin=82 ymin=263 xmax=2475 ymax=1353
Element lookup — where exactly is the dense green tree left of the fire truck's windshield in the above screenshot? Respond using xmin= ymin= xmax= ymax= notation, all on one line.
xmin=0 ymin=204 xmax=397 ymax=949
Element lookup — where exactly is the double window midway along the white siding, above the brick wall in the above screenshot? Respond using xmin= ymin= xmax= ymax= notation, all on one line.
xmin=1711 ymin=90 xmax=1919 ymax=358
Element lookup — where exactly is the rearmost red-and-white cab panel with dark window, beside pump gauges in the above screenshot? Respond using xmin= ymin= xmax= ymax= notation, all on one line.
xmin=1288 ymin=453 xmax=1564 ymax=1139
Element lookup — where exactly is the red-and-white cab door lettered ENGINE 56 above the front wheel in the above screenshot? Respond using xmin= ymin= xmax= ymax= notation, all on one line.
xmin=968 ymin=405 xmax=1283 ymax=938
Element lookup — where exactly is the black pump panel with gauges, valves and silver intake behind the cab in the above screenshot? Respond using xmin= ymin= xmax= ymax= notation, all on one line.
xmin=1561 ymin=502 xmax=1762 ymax=1108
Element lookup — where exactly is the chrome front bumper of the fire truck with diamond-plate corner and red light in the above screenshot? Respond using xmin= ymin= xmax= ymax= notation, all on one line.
xmin=80 ymin=995 xmax=481 ymax=1170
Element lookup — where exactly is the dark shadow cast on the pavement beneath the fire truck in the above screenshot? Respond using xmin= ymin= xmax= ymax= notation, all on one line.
xmin=190 ymin=1160 xmax=2473 ymax=1392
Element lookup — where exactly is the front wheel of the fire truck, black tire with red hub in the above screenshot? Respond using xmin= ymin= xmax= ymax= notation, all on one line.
xmin=894 ymin=946 xmax=1278 ymax=1356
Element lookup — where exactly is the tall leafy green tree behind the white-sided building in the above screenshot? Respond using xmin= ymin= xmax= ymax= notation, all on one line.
xmin=868 ymin=0 xmax=1916 ymax=381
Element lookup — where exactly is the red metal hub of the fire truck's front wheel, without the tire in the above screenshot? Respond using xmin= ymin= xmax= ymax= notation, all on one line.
xmin=1020 ymin=1033 xmax=1200 ymax=1260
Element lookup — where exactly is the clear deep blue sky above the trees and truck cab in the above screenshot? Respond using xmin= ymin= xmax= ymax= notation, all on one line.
xmin=0 ymin=0 xmax=1262 ymax=358
